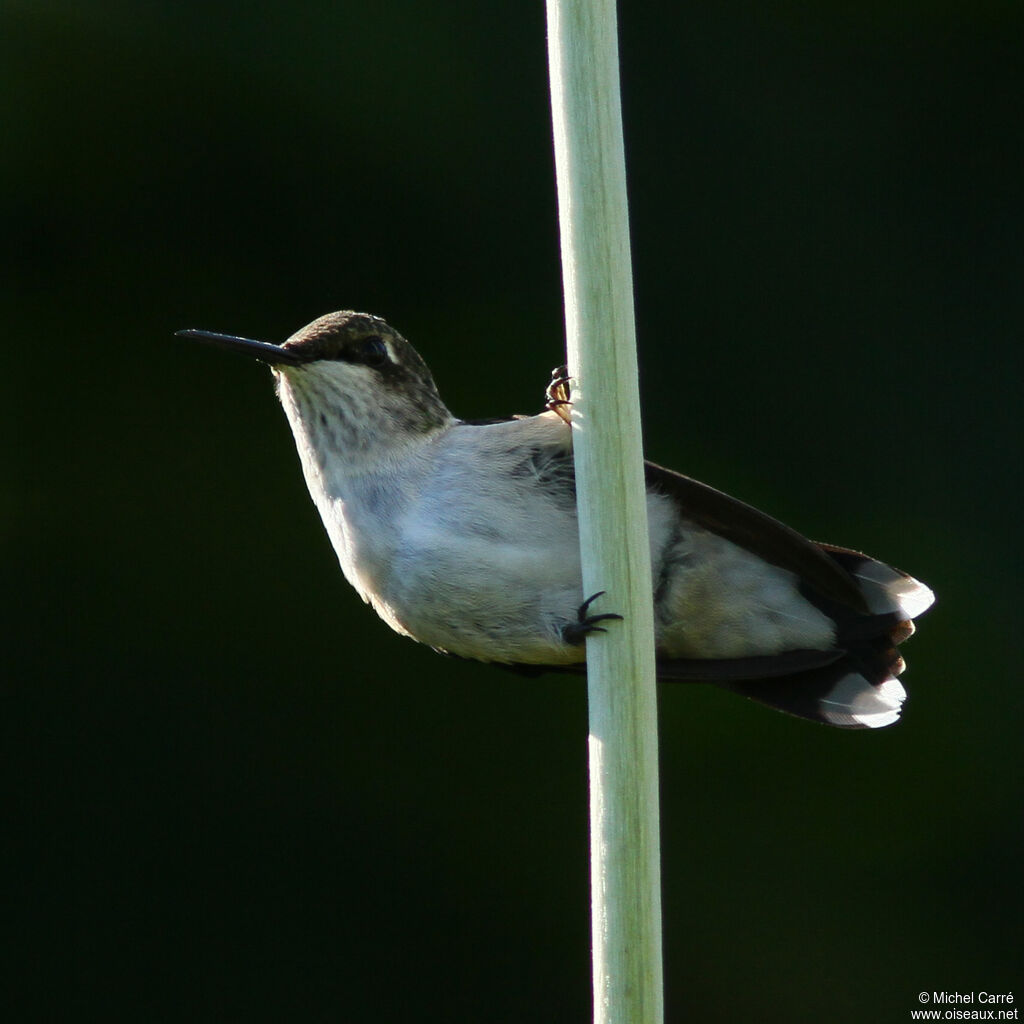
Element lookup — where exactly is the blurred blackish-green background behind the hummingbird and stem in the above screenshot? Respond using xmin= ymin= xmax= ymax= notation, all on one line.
xmin=0 ymin=0 xmax=1024 ymax=1022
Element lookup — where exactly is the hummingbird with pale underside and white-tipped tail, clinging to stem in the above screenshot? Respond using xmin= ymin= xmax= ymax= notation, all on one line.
xmin=179 ymin=310 xmax=933 ymax=728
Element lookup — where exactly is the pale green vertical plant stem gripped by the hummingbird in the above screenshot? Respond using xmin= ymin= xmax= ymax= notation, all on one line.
xmin=547 ymin=0 xmax=664 ymax=1024
